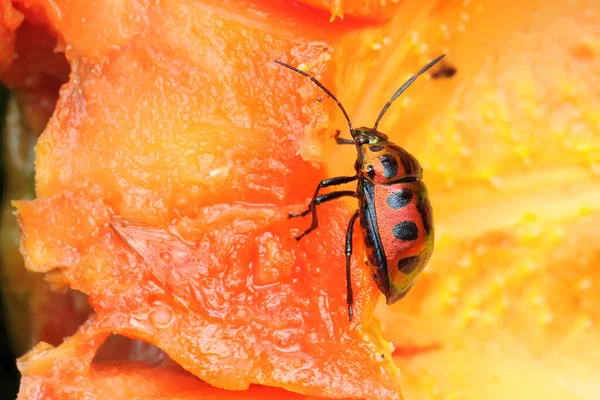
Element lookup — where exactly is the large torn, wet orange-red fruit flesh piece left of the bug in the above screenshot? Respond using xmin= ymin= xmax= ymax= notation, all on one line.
xmin=11 ymin=2 xmax=401 ymax=399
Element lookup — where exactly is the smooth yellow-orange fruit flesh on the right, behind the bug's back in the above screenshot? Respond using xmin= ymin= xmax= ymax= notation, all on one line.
xmin=330 ymin=0 xmax=600 ymax=399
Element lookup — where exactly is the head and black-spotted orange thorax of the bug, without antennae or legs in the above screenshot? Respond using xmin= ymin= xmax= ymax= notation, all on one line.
xmin=355 ymin=128 xmax=423 ymax=184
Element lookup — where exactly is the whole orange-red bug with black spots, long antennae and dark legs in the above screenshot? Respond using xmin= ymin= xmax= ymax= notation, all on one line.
xmin=275 ymin=55 xmax=444 ymax=321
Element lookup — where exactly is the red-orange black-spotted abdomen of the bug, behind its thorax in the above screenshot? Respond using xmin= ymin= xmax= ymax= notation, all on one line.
xmin=373 ymin=181 xmax=433 ymax=304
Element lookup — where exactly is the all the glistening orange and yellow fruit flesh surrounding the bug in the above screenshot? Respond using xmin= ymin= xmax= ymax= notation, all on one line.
xmin=0 ymin=0 xmax=600 ymax=400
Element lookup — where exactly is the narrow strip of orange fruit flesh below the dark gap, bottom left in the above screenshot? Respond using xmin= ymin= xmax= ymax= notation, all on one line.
xmin=18 ymin=318 xmax=342 ymax=400
